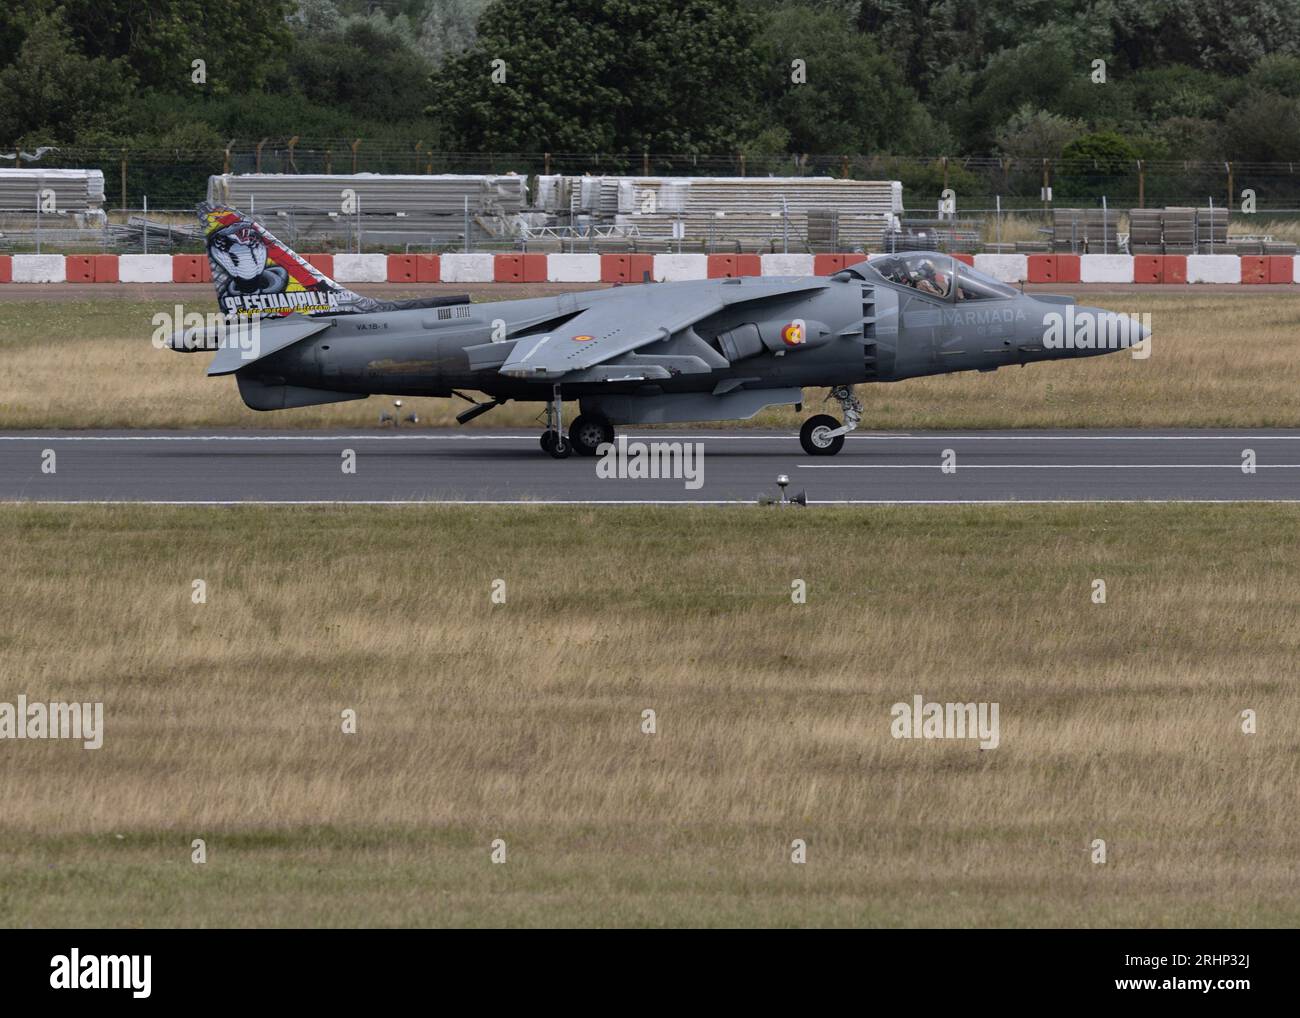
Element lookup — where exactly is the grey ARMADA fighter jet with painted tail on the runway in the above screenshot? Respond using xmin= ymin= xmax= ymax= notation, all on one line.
xmin=168 ymin=204 xmax=1147 ymax=459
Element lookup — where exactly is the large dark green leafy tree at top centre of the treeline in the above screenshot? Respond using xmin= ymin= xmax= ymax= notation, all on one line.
xmin=429 ymin=0 xmax=759 ymax=155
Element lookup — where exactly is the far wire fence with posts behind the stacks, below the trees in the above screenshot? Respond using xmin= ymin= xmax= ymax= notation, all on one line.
xmin=15 ymin=138 xmax=1300 ymax=211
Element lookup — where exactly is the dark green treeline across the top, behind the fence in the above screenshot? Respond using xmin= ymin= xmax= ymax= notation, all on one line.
xmin=0 ymin=0 xmax=1300 ymax=166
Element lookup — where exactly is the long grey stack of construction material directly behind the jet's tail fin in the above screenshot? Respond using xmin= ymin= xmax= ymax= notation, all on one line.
xmin=208 ymin=173 xmax=527 ymax=251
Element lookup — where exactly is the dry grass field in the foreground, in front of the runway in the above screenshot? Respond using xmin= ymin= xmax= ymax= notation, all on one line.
xmin=0 ymin=504 xmax=1300 ymax=927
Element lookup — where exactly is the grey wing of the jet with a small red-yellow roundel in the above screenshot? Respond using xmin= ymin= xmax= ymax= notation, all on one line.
xmin=501 ymin=277 xmax=827 ymax=380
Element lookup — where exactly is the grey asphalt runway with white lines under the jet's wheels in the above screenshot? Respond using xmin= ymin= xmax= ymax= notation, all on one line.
xmin=0 ymin=428 xmax=1300 ymax=506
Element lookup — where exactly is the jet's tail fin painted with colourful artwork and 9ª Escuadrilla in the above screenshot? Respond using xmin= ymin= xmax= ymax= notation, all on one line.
xmin=199 ymin=203 xmax=380 ymax=317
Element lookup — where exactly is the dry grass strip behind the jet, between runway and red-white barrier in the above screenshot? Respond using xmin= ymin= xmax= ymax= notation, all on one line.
xmin=0 ymin=287 xmax=1300 ymax=429
